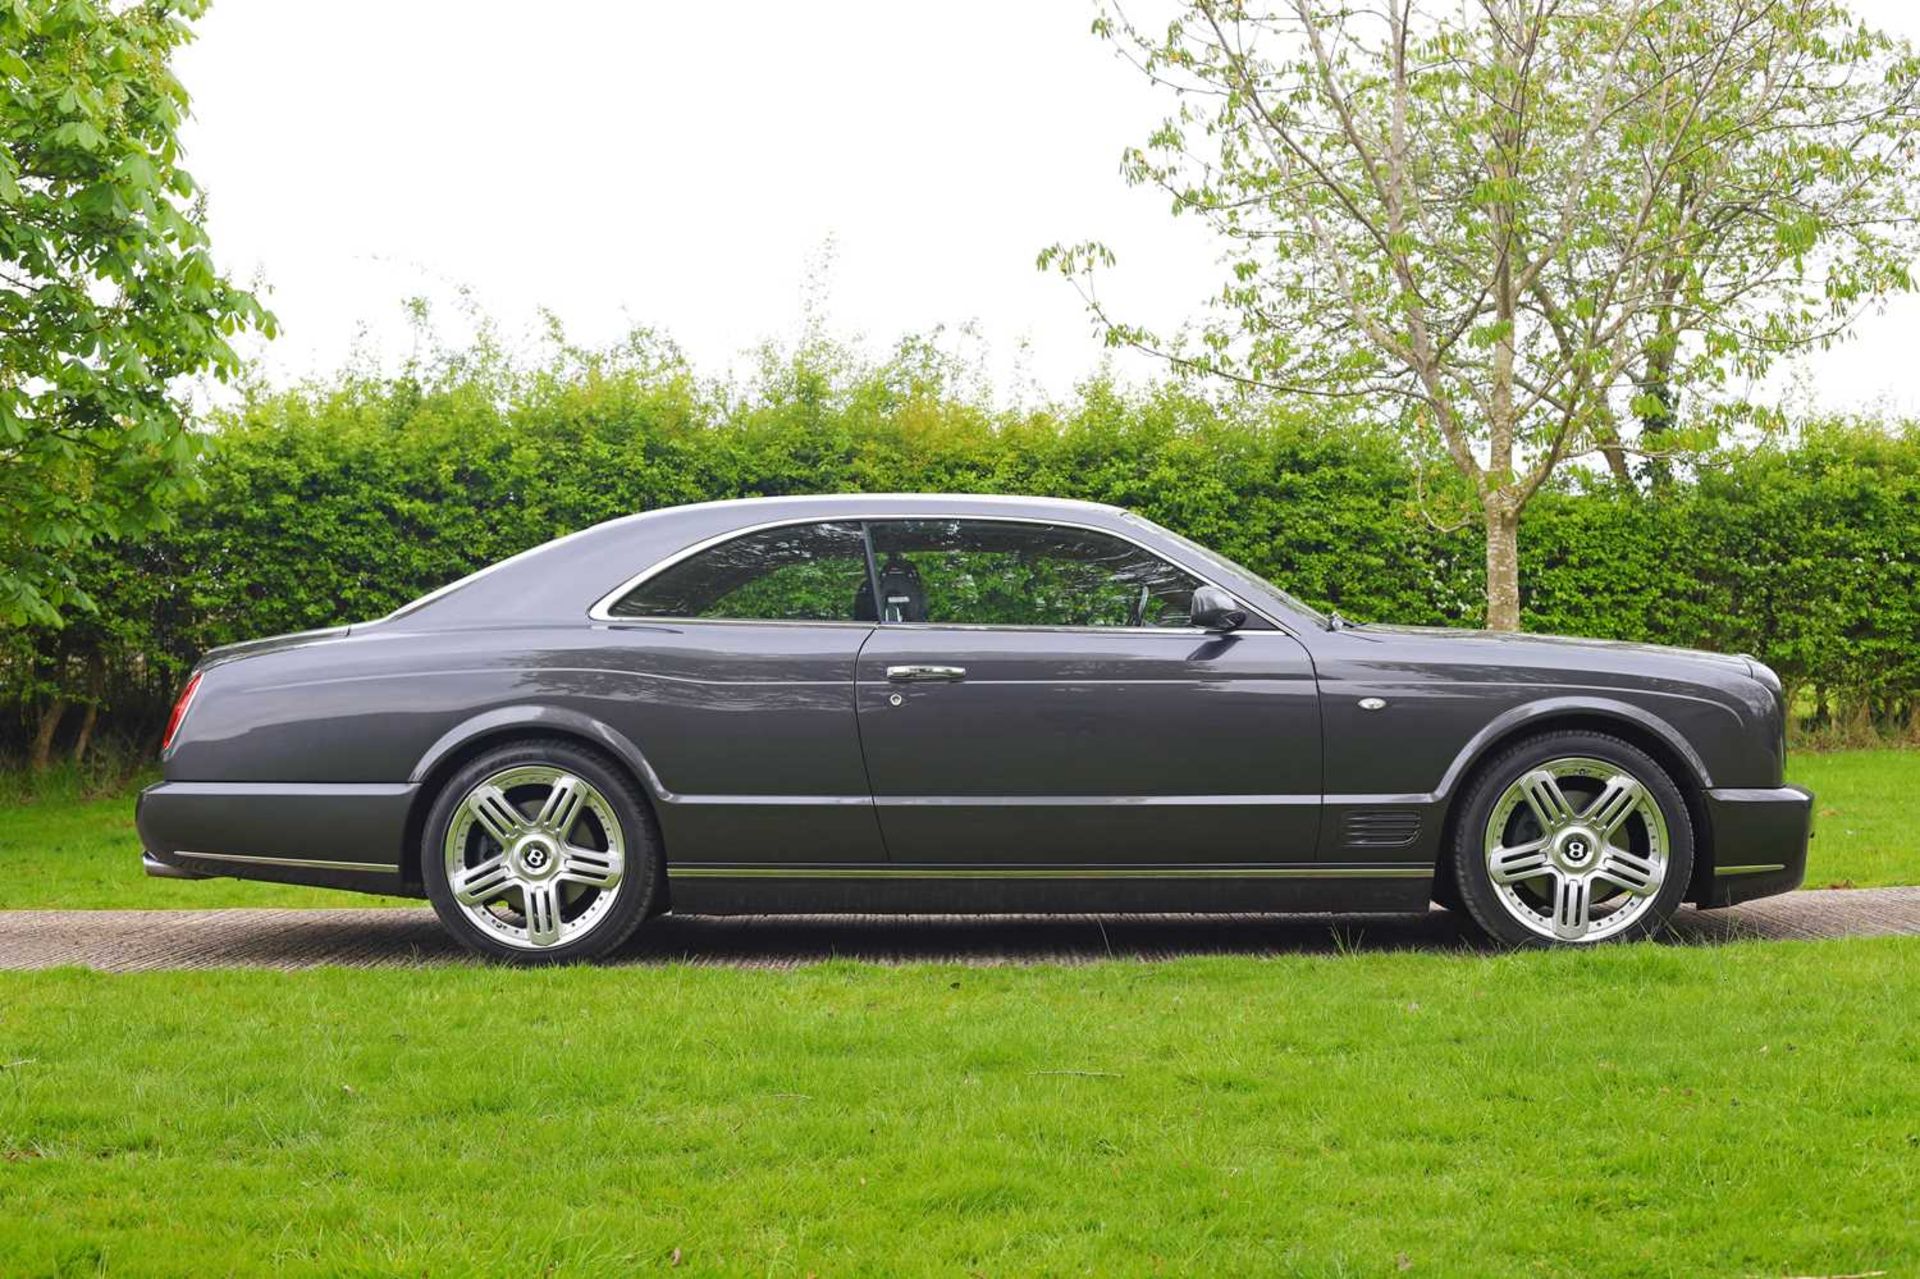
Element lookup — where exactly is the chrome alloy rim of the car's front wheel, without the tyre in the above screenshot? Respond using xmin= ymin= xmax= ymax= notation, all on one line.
xmin=1484 ymin=757 xmax=1670 ymax=941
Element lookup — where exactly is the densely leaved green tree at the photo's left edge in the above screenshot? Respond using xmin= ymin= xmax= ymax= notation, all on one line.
xmin=0 ymin=0 xmax=273 ymax=626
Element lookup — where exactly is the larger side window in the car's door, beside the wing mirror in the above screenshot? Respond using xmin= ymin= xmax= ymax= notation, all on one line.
xmin=872 ymin=520 xmax=1198 ymax=626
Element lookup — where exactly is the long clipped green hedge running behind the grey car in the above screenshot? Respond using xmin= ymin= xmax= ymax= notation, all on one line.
xmin=0 ymin=342 xmax=1920 ymax=751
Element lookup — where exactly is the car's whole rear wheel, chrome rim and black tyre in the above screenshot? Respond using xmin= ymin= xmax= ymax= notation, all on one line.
xmin=420 ymin=741 xmax=660 ymax=964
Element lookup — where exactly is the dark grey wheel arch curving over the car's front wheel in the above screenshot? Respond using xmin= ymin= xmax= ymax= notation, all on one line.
xmin=1434 ymin=697 xmax=1713 ymax=901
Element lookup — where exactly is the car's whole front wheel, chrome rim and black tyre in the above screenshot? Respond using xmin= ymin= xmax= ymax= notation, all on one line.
xmin=1452 ymin=732 xmax=1693 ymax=947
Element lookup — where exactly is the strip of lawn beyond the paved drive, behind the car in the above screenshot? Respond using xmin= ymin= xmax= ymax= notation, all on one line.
xmin=0 ymin=751 xmax=1920 ymax=910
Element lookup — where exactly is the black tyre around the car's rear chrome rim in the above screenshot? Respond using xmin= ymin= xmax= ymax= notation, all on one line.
xmin=420 ymin=741 xmax=660 ymax=964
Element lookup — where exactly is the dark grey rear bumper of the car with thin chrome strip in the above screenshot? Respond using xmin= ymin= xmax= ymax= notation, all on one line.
xmin=134 ymin=782 xmax=419 ymax=893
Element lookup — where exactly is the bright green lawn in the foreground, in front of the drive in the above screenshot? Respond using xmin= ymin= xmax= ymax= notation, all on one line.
xmin=0 ymin=939 xmax=1920 ymax=1279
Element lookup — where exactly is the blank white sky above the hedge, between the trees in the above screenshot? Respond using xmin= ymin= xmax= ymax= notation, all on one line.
xmin=177 ymin=0 xmax=1920 ymax=415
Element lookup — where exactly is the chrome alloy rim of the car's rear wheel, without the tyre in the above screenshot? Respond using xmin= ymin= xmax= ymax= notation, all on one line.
xmin=444 ymin=764 xmax=626 ymax=951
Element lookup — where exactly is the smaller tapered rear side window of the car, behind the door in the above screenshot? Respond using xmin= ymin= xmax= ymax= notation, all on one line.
xmin=609 ymin=524 xmax=872 ymax=622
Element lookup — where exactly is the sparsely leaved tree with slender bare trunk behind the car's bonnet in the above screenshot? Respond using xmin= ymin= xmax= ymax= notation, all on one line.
xmin=1041 ymin=0 xmax=1920 ymax=630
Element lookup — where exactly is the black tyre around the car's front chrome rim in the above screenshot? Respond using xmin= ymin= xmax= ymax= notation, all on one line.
xmin=1452 ymin=732 xmax=1693 ymax=947
